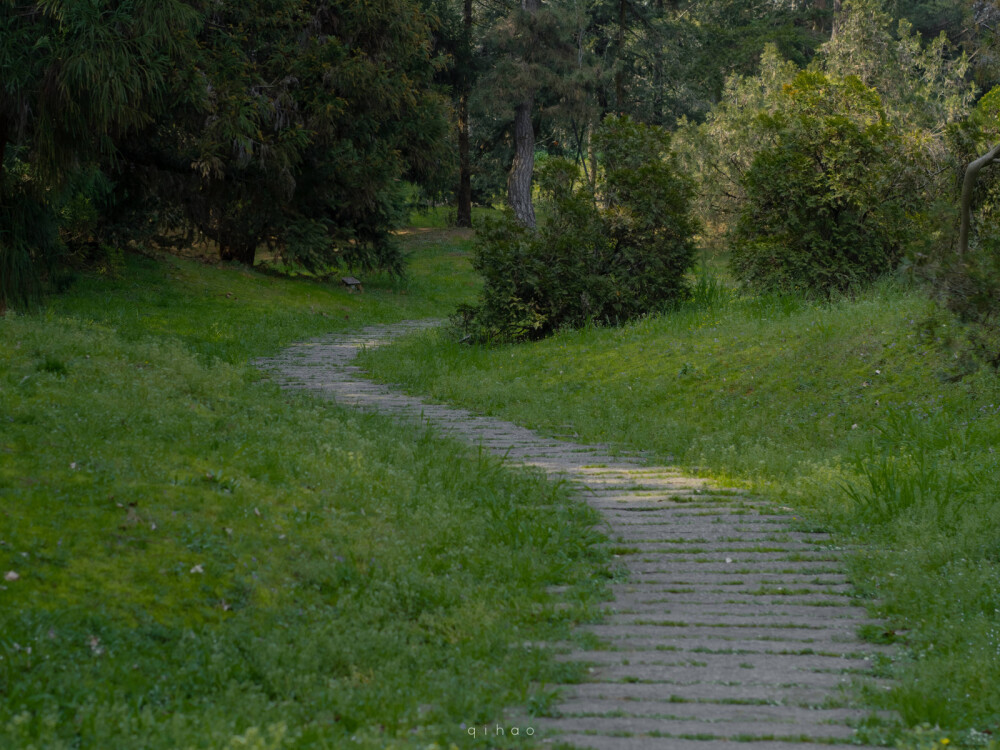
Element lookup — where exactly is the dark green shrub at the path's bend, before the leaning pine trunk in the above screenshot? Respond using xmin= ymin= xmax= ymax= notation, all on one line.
xmin=459 ymin=117 xmax=695 ymax=341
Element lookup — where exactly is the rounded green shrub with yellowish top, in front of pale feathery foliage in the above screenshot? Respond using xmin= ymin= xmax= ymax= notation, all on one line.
xmin=730 ymin=72 xmax=920 ymax=293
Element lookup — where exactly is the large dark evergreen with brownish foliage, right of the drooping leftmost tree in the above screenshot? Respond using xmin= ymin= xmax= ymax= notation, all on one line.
xmin=114 ymin=0 xmax=447 ymax=272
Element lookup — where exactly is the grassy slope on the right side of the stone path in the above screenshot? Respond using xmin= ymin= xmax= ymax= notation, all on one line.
xmin=362 ymin=281 xmax=1000 ymax=746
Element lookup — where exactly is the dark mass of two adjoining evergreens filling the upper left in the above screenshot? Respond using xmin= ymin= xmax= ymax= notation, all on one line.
xmin=0 ymin=0 xmax=449 ymax=305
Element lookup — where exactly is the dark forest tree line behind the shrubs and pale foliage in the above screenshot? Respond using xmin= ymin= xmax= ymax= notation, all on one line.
xmin=0 ymin=0 xmax=1000 ymax=306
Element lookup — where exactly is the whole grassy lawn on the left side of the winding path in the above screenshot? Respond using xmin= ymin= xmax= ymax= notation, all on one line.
xmin=0 ymin=233 xmax=601 ymax=750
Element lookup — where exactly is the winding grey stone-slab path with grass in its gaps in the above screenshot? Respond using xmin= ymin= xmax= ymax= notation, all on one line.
xmin=259 ymin=321 xmax=892 ymax=750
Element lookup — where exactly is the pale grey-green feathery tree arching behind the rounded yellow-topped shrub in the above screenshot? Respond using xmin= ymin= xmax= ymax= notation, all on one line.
xmin=677 ymin=0 xmax=975 ymax=258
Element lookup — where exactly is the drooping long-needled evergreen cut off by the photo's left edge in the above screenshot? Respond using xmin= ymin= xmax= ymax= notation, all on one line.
xmin=0 ymin=0 xmax=197 ymax=310
